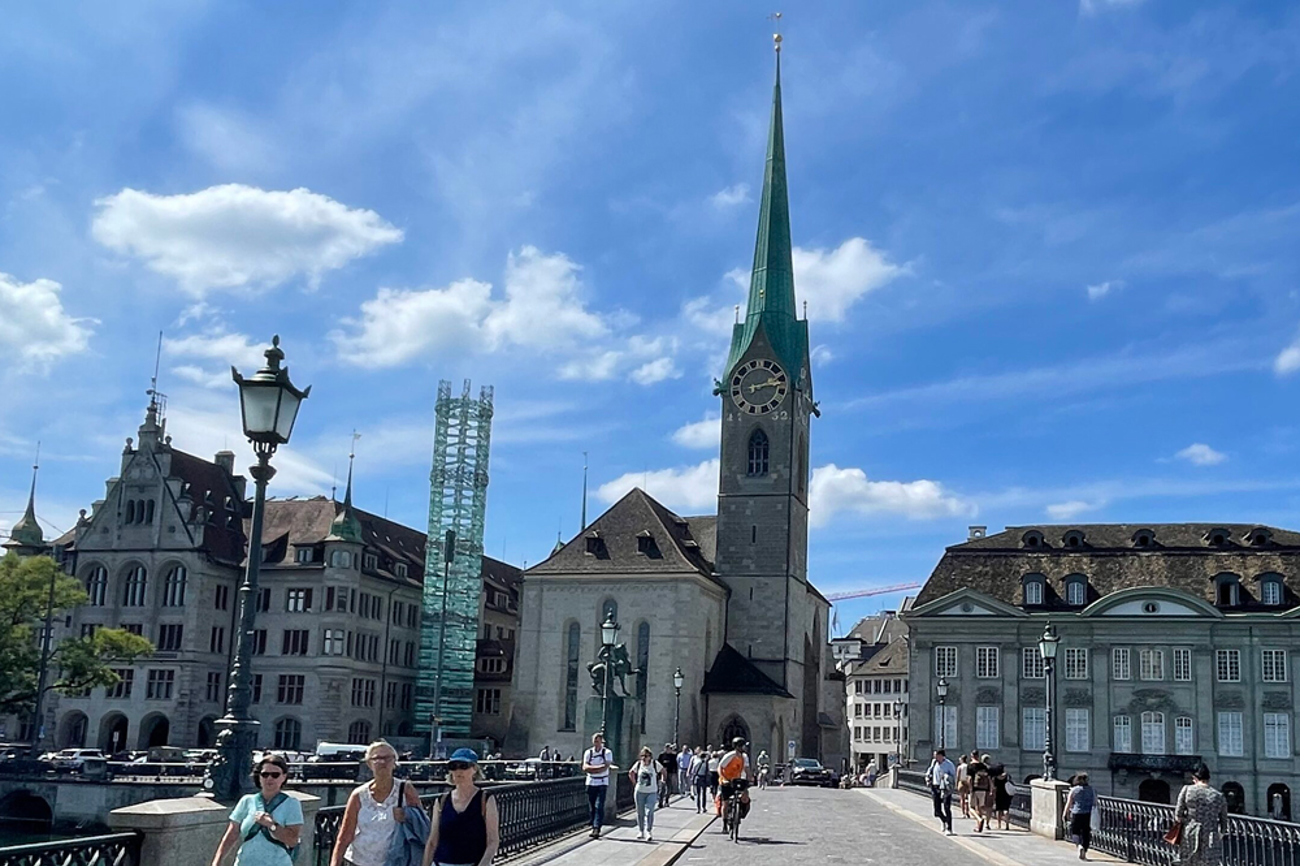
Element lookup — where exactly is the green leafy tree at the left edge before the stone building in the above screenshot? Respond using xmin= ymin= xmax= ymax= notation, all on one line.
xmin=0 ymin=553 xmax=153 ymax=714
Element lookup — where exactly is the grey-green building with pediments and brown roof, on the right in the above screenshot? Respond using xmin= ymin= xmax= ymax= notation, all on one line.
xmin=905 ymin=524 xmax=1300 ymax=818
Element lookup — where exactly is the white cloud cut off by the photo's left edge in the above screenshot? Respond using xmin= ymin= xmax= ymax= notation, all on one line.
xmin=0 ymin=273 xmax=99 ymax=369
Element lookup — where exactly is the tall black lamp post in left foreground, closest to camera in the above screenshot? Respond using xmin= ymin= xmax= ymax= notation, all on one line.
xmin=209 ymin=337 xmax=312 ymax=802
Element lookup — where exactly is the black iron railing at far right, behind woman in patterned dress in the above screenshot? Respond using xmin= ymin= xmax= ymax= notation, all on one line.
xmin=1092 ymin=797 xmax=1300 ymax=866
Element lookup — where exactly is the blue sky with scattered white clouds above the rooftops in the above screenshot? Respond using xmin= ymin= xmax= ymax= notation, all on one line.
xmin=0 ymin=0 xmax=1300 ymax=622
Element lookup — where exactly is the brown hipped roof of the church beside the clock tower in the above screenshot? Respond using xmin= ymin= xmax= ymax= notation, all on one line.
xmin=528 ymin=488 xmax=716 ymax=579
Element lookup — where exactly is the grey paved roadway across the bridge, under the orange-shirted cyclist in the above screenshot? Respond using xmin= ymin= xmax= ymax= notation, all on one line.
xmin=677 ymin=788 xmax=988 ymax=866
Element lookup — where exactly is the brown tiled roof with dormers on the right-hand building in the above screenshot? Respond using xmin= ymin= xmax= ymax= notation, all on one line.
xmin=917 ymin=523 xmax=1300 ymax=610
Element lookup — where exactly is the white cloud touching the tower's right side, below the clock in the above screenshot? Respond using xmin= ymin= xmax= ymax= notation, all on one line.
xmin=809 ymin=463 xmax=975 ymax=527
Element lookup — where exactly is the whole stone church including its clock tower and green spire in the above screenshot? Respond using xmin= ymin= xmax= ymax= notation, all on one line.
xmin=507 ymin=55 xmax=842 ymax=766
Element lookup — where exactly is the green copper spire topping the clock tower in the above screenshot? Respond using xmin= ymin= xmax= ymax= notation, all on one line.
xmin=724 ymin=52 xmax=807 ymax=387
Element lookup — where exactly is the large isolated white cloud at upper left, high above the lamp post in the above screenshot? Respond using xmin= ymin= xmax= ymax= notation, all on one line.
xmin=91 ymin=183 xmax=403 ymax=296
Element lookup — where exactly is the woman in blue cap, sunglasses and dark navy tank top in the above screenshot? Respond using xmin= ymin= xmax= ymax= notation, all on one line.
xmin=424 ymin=749 xmax=501 ymax=866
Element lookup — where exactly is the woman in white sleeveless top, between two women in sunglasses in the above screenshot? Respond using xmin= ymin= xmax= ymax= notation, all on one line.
xmin=329 ymin=740 xmax=420 ymax=866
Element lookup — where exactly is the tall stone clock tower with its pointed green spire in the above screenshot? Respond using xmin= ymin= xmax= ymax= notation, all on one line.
xmin=715 ymin=38 xmax=816 ymax=694
